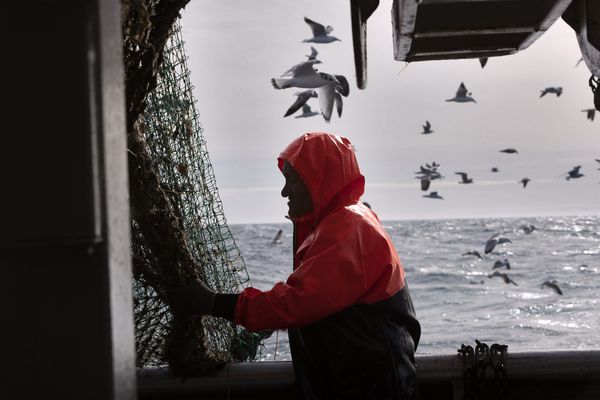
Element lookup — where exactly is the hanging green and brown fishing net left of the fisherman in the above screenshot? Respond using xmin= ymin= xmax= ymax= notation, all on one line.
xmin=124 ymin=0 xmax=262 ymax=374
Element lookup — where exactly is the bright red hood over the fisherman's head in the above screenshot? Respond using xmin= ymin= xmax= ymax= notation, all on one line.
xmin=277 ymin=132 xmax=365 ymax=219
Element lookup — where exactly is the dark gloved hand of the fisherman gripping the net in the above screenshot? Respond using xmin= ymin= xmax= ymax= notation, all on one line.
xmin=173 ymin=279 xmax=216 ymax=315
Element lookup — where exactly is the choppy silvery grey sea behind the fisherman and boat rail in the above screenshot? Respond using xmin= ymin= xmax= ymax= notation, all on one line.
xmin=230 ymin=216 xmax=600 ymax=361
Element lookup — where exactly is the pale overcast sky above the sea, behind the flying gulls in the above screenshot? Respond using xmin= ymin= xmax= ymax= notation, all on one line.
xmin=182 ymin=0 xmax=600 ymax=223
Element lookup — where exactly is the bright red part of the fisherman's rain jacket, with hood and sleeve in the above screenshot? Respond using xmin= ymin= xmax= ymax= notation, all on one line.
xmin=234 ymin=133 xmax=405 ymax=331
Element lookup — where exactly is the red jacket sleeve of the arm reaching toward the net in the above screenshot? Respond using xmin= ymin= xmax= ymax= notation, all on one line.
xmin=234 ymin=212 xmax=397 ymax=331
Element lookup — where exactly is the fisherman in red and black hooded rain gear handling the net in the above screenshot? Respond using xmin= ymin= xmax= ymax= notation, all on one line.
xmin=182 ymin=133 xmax=421 ymax=399
